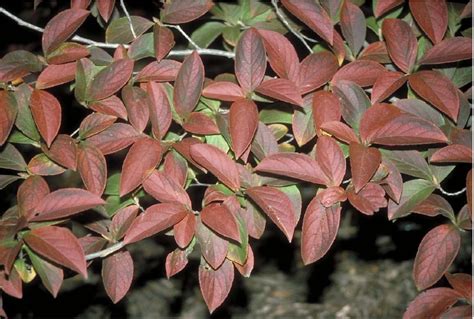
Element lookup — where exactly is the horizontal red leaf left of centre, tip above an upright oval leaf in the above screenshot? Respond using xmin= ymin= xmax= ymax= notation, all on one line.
xmin=87 ymin=123 xmax=140 ymax=155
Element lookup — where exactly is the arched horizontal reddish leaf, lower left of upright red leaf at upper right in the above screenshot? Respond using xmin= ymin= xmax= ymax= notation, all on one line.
xmin=331 ymin=60 xmax=386 ymax=87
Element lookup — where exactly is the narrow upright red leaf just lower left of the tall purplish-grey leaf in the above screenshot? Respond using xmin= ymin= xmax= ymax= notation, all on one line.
xmin=146 ymin=82 xmax=171 ymax=138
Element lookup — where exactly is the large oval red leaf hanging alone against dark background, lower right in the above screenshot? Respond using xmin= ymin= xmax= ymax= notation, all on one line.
xmin=413 ymin=225 xmax=461 ymax=290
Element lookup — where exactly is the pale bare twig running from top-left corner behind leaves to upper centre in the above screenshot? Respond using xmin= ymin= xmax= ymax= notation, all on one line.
xmin=0 ymin=7 xmax=235 ymax=59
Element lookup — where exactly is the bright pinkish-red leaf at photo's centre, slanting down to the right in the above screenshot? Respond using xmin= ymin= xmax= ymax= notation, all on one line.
xmin=190 ymin=144 xmax=240 ymax=191
